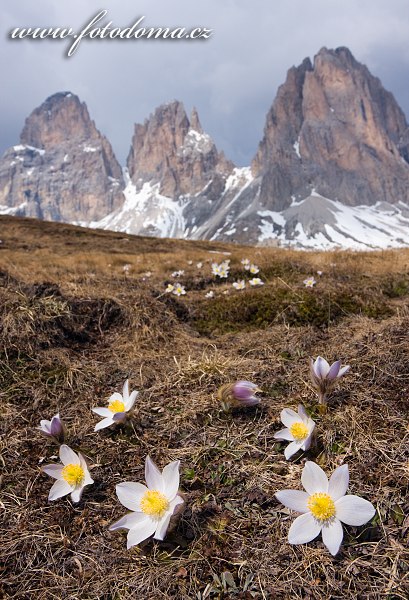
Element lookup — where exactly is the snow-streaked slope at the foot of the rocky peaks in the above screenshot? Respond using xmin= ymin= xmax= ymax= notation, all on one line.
xmin=89 ymin=168 xmax=409 ymax=250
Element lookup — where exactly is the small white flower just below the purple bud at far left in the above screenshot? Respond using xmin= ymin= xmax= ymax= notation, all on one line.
xmin=41 ymin=444 xmax=94 ymax=502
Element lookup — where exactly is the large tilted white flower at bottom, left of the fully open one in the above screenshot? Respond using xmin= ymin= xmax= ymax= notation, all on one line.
xmin=109 ymin=456 xmax=183 ymax=548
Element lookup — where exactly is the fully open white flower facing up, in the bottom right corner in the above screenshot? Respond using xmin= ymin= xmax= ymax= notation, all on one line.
xmin=275 ymin=461 xmax=375 ymax=556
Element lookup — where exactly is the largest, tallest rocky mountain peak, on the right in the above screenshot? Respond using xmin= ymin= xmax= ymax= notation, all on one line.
xmin=252 ymin=48 xmax=409 ymax=210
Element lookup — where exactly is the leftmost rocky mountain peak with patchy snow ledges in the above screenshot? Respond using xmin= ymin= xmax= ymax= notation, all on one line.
xmin=0 ymin=92 xmax=124 ymax=222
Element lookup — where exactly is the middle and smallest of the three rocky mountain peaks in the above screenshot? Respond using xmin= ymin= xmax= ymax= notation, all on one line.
xmin=127 ymin=100 xmax=234 ymax=198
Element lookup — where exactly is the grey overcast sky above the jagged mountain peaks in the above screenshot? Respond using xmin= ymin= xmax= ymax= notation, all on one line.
xmin=0 ymin=0 xmax=409 ymax=165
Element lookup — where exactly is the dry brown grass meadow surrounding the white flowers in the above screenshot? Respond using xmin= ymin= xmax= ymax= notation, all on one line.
xmin=0 ymin=217 xmax=409 ymax=600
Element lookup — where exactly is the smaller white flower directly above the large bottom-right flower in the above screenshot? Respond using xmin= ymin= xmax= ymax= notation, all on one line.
xmin=274 ymin=404 xmax=315 ymax=460
